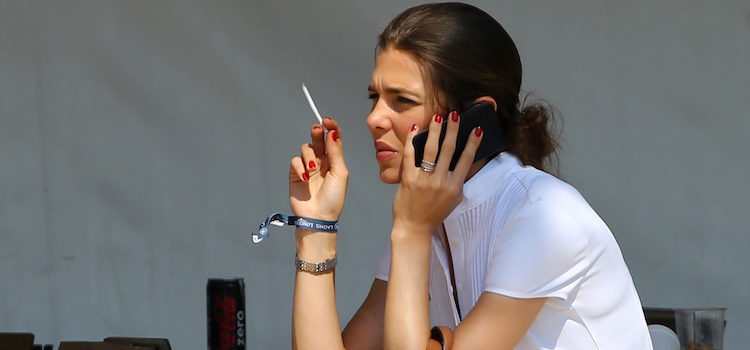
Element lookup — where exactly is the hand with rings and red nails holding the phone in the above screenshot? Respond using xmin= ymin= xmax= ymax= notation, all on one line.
xmin=393 ymin=112 xmax=482 ymax=234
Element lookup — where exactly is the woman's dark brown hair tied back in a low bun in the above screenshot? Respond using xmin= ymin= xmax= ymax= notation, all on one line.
xmin=378 ymin=3 xmax=558 ymax=172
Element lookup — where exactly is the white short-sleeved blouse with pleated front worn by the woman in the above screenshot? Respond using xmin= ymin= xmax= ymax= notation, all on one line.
xmin=375 ymin=152 xmax=652 ymax=350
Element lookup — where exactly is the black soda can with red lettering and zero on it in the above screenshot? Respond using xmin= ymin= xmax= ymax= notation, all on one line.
xmin=206 ymin=278 xmax=246 ymax=350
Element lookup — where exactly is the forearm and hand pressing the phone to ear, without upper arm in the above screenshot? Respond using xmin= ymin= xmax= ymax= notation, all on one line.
xmin=384 ymin=112 xmax=482 ymax=350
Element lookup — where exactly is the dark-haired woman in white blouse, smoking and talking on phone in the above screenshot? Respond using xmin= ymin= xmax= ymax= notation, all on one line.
xmin=289 ymin=3 xmax=651 ymax=349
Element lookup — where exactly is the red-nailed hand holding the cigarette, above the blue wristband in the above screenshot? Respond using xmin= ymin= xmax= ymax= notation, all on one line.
xmin=289 ymin=117 xmax=349 ymax=221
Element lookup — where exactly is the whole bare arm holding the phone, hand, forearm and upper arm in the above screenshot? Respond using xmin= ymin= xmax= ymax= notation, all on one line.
xmin=385 ymin=111 xmax=546 ymax=350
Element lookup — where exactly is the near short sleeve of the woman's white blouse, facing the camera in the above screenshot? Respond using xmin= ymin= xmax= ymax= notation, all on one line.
xmin=485 ymin=201 xmax=590 ymax=300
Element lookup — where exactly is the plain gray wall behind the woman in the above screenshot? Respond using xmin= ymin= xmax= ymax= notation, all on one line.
xmin=0 ymin=0 xmax=750 ymax=349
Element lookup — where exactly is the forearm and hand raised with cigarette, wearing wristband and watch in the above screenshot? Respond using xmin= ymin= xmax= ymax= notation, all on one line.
xmin=289 ymin=118 xmax=349 ymax=350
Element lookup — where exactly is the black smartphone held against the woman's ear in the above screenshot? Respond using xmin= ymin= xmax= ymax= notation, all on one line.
xmin=412 ymin=102 xmax=505 ymax=171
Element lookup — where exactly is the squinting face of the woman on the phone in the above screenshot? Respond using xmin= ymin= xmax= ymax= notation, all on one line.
xmin=367 ymin=49 xmax=435 ymax=184
